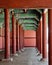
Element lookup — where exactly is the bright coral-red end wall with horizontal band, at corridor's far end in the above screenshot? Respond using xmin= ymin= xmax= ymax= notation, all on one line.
xmin=24 ymin=30 xmax=36 ymax=47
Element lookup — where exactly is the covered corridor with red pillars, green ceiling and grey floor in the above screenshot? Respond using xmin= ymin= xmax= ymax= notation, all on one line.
xmin=0 ymin=8 xmax=52 ymax=65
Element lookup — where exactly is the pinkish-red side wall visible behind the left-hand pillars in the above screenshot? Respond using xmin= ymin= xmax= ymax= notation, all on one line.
xmin=0 ymin=28 xmax=12 ymax=49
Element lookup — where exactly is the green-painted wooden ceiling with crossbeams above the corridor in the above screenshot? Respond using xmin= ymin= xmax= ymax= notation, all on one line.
xmin=0 ymin=8 xmax=43 ymax=30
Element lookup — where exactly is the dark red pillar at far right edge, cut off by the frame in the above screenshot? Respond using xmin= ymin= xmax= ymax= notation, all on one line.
xmin=48 ymin=9 xmax=52 ymax=65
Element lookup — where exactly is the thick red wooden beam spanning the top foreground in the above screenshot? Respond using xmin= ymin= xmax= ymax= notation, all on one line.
xmin=0 ymin=0 xmax=52 ymax=8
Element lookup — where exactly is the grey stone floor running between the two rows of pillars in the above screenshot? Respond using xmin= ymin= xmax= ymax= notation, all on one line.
xmin=0 ymin=48 xmax=48 ymax=65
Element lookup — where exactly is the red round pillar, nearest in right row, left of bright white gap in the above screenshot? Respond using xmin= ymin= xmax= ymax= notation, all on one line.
xmin=42 ymin=12 xmax=47 ymax=58
